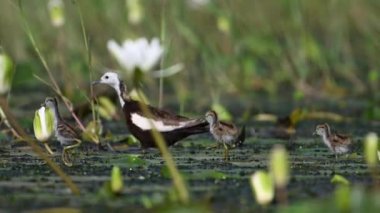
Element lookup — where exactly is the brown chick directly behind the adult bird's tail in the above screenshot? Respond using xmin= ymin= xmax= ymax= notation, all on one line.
xmin=205 ymin=110 xmax=245 ymax=160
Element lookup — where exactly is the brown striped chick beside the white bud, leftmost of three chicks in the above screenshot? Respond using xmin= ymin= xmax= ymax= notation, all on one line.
xmin=44 ymin=97 xmax=81 ymax=166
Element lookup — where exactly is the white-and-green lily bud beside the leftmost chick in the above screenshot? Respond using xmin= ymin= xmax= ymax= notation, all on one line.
xmin=33 ymin=107 xmax=54 ymax=142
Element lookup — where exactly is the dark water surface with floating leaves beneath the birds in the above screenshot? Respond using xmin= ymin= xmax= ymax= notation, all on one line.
xmin=0 ymin=91 xmax=379 ymax=212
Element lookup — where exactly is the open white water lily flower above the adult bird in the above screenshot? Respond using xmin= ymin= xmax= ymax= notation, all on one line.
xmin=107 ymin=38 xmax=164 ymax=72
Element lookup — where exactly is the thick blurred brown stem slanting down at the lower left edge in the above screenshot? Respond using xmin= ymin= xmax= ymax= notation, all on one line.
xmin=0 ymin=97 xmax=80 ymax=195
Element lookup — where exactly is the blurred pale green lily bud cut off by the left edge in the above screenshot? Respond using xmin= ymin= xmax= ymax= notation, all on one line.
xmin=0 ymin=53 xmax=13 ymax=95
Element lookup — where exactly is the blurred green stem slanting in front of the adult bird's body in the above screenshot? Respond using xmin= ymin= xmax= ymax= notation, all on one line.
xmin=136 ymin=89 xmax=190 ymax=204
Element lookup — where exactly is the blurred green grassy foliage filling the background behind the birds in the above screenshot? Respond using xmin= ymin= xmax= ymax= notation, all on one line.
xmin=0 ymin=0 xmax=380 ymax=111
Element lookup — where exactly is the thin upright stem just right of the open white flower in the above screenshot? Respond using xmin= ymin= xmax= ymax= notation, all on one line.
xmin=158 ymin=0 xmax=166 ymax=108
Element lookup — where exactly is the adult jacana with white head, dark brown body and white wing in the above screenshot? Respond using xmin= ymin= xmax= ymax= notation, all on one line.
xmin=93 ymin=72 xmax=208 ymax=148
